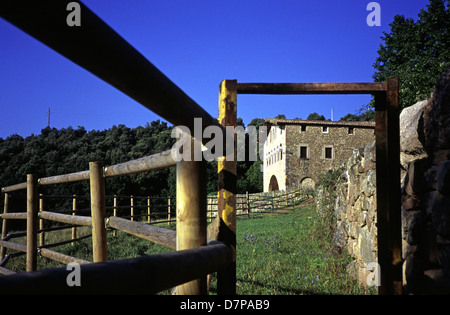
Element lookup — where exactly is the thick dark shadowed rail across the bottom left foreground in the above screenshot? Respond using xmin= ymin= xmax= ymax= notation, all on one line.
xmin=0 ymin=242 xmax=233 ymax=295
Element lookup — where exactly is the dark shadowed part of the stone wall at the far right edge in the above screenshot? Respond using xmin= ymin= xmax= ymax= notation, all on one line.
xmin=402 ymin=69 xmax=450 ymax=294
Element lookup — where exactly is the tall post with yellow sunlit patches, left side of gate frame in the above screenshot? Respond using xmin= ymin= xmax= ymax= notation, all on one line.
xmin=217 ymin=80 xmax=237 ymax=294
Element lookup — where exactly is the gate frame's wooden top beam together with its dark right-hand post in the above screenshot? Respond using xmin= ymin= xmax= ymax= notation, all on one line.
xmin=223 ymin=78 xmax=402 ymax=294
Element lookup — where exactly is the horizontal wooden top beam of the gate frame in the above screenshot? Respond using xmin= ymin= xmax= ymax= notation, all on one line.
xmin=237 ymin=83 xmax=387 ymax=94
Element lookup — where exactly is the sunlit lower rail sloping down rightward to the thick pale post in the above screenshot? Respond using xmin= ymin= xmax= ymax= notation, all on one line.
xmin=106 ymin=217 xmax=176 ymax=249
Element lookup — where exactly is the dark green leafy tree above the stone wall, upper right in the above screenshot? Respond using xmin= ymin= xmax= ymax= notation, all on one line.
xmin=373 ymin=0 xmax=450 ymax=109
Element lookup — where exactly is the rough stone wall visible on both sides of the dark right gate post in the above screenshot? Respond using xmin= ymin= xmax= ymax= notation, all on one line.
xmin=316 ymin=69 xmax=450 ymax=294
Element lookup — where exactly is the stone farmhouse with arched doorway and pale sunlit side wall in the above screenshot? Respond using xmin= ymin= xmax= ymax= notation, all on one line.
xmin=263 ymin=119 xmax=375 ymax=192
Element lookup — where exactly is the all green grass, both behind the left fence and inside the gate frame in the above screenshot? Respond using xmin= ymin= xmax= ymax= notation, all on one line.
xmin=3 ymin=201 xmax=374 ymax=295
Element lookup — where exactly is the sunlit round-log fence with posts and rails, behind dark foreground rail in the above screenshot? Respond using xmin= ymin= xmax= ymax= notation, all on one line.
xmin=0 ymin=144 xmax=230 ymax=294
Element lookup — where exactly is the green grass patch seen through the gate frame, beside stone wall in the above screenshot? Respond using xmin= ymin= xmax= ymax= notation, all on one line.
xmin=236 ymin=207 xmax=374 ymax=295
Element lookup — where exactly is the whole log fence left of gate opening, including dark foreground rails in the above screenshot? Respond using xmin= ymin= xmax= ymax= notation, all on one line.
xmin=0 ymin=0 xmax=236 ymax=294
